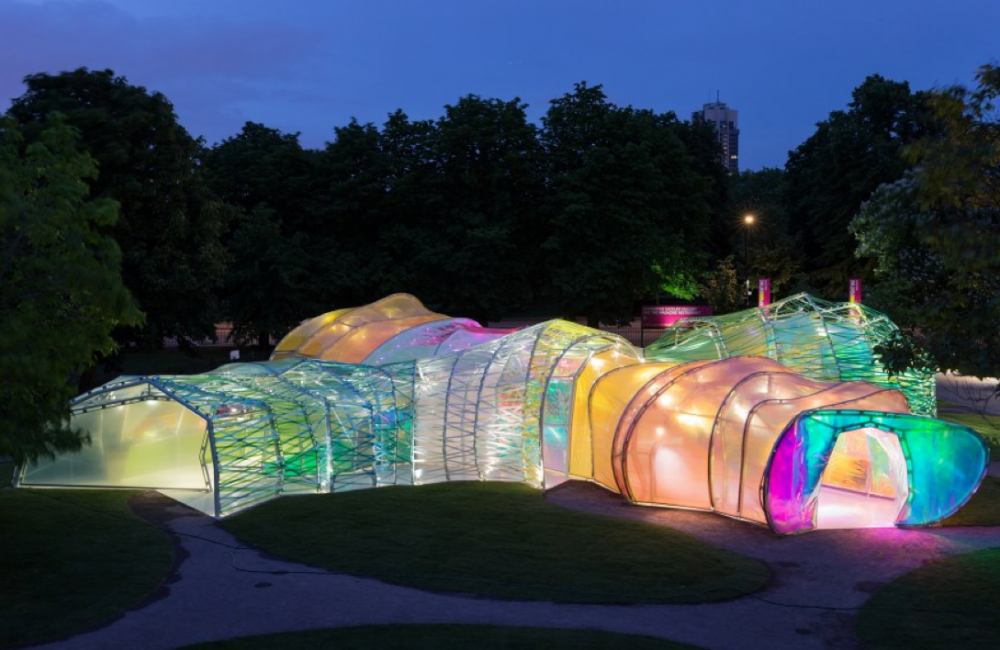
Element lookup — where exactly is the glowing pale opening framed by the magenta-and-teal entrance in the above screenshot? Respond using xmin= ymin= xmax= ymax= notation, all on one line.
xmin=816 ymin=427 xmax=909 ymax=529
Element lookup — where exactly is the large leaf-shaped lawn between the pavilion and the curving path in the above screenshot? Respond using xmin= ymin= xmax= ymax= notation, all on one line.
xmin=223 ymin=482 xmax=769 ymax=603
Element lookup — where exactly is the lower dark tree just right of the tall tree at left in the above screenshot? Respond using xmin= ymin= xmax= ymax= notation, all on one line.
xmin=205 ymin=122 xmax=324 ymax=348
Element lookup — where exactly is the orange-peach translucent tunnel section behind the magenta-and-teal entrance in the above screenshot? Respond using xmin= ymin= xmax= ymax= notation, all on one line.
xmin=573 ymin=357 xmax=908 ymax=523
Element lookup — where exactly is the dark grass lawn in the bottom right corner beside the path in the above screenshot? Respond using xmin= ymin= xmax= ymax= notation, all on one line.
xmin=858 ymin=548 xmax=1000 ymax=650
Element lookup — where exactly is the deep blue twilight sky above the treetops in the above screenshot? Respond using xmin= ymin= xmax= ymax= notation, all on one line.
xmin=0 ymin=0 xmax=1000 ymax=169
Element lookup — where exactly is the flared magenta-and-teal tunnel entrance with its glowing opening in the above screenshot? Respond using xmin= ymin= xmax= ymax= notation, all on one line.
xmin=760 ymin=409 xmax=989 ymax=534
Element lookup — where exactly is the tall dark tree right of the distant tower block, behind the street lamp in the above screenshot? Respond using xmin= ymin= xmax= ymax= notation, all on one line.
xmin=785 ymin=75 xmax=935 ymax=297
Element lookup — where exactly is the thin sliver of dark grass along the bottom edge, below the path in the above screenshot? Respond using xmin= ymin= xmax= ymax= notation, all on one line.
xmin=174 ymin=625 xmax=698 ymax=650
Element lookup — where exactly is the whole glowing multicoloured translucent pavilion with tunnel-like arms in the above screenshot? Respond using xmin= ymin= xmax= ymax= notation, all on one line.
xmin=20 ymin=295 xmax=988 ymax=533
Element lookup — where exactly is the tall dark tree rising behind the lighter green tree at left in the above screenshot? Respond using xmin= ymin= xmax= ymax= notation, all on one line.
xmin=10 ymin=68 xmax=231 ymax=347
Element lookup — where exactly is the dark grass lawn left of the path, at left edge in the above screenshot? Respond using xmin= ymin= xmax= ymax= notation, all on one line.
xmin=0 ymin=470 xmax=173 ymax=648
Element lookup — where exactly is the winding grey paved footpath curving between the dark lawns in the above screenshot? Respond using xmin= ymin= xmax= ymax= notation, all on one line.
xmin=25 ymin=482 xmax=1000 ymax=650
